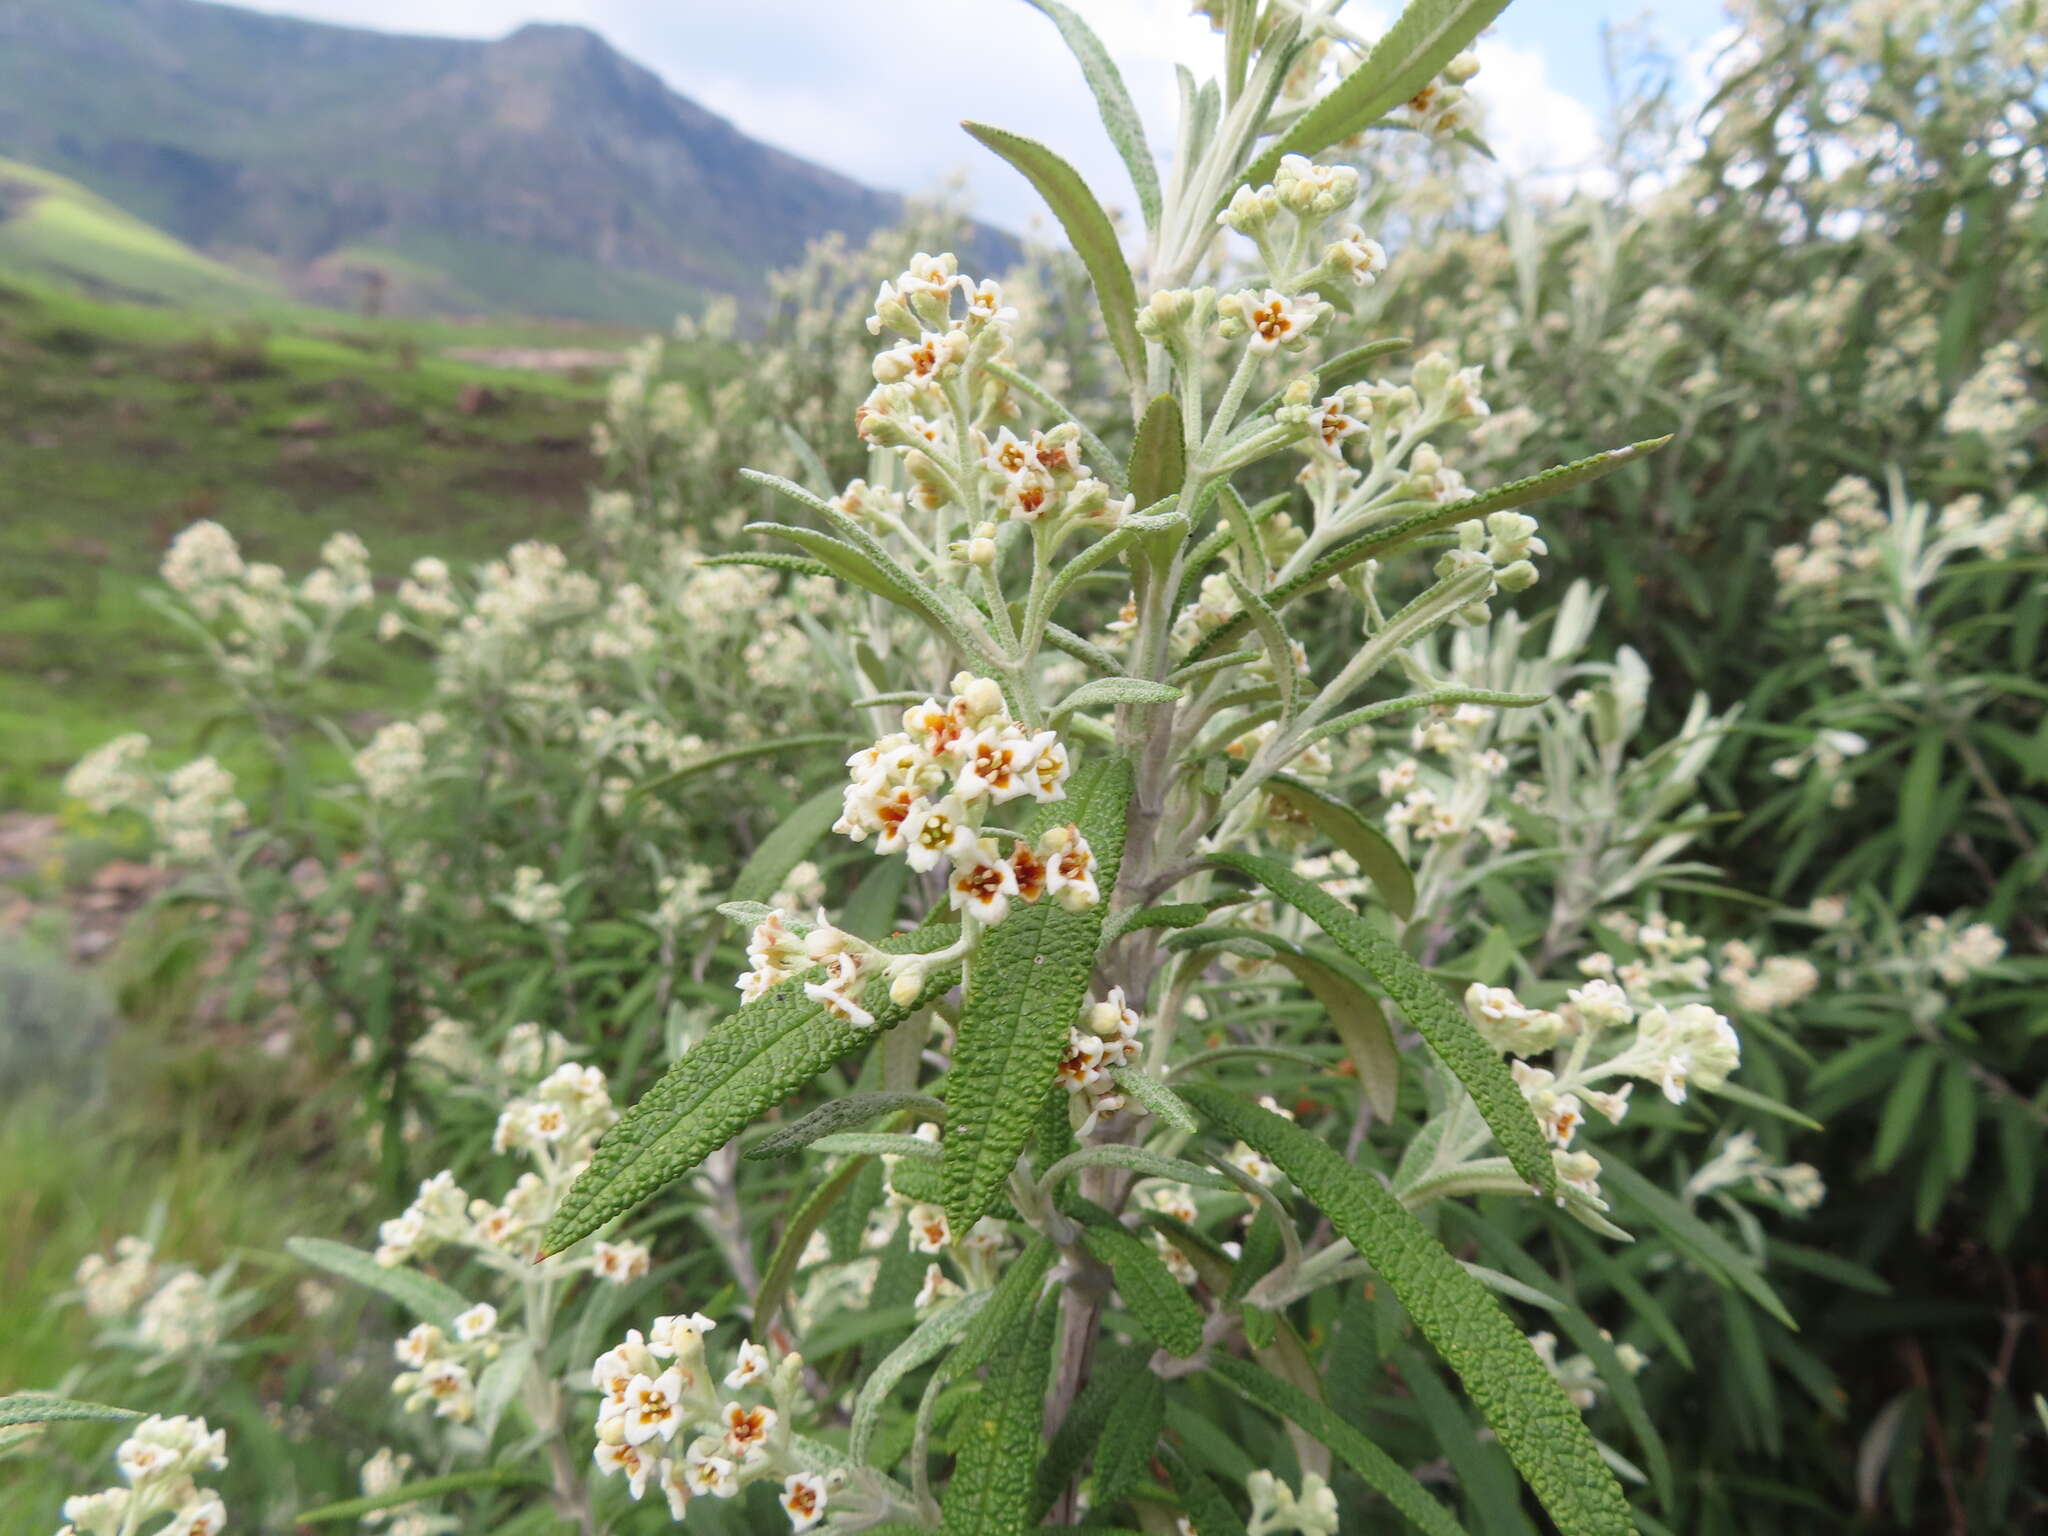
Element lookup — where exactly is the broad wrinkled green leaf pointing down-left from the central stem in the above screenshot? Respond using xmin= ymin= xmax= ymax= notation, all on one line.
xmin=543 ymin=928 xmax=958 ymax=1253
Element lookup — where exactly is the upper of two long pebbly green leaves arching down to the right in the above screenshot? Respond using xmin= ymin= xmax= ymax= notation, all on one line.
xmin=1210 ymin=852 xmax=1556 ymax=1194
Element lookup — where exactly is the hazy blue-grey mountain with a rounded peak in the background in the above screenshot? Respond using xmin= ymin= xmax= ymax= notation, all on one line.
xmin=0 ymin=0 xmax=1008 ymax=324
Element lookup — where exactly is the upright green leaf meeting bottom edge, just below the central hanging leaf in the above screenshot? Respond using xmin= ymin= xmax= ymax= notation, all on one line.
xmin=942 ymin=1300 xmax=1059 ymax=1536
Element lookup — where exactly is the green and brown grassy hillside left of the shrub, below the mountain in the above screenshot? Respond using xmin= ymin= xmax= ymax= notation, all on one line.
xmin=0 ymin=272 xmax=627 ymax=809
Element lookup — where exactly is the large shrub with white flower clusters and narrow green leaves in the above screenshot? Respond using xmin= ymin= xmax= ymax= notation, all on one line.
xmin=32 ymin=0 xmax=2044 ymax=1536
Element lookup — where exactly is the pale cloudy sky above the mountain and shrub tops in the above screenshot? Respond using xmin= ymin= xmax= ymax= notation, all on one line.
xmin=199 ymin=0 xmax=1722 ymax=229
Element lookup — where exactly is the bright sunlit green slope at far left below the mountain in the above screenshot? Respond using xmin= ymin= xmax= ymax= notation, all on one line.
xmin=0 ymin=160 xmax=276 ymax=311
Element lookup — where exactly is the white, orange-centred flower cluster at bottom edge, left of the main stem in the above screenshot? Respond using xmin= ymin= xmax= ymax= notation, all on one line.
xmin=590 ymin=1313 xmax=836 ymax=1532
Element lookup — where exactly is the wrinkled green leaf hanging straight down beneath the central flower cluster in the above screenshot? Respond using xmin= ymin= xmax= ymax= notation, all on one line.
xmin=944 ymin=758 xmax=1130 ymax=1233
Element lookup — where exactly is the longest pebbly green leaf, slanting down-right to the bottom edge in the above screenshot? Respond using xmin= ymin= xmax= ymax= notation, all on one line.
xmin=1182 ymin=1085 xmax=1634 ymax=1536
